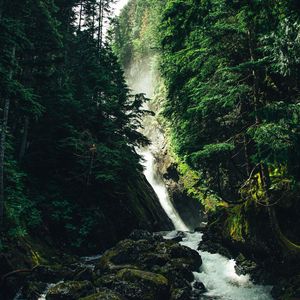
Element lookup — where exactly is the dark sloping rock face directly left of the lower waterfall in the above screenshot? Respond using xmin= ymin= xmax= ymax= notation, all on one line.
xmin=59 ymin=173 xmax=173 ymax=255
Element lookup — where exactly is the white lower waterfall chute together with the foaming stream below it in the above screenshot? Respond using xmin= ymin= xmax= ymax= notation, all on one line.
xmin=142 ymin=145 xmax=272 ymax=300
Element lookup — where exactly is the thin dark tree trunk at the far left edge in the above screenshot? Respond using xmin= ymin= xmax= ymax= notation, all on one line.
xmin=0 ymin=47 xmax=16 ymax=227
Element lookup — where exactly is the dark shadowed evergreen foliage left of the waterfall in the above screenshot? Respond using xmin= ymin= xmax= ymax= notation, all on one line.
xmin=0 ymin=0 xmax=148 ymax=247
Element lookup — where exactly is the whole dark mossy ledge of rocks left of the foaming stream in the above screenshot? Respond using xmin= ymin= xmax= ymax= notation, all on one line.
xmin=11 ymin=231 xmax=204 ymax=300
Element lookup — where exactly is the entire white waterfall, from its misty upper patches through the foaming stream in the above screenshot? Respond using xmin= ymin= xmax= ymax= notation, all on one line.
xmin=129 ymin=62 xmax=272 ymax=300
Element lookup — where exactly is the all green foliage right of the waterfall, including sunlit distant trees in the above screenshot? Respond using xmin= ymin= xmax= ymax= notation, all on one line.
xmin=114 ymin=0 xmax=300 ymax=248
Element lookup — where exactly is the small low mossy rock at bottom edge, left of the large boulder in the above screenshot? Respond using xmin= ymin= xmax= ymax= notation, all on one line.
xmin=46 ymin=281 xmax=95 ymax=300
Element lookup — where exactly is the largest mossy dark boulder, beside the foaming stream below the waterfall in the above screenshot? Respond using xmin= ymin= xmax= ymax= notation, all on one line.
xmin=94 ymin=234 xmax=202 ymax=300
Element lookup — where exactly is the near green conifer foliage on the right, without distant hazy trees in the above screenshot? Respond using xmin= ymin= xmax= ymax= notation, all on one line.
xmin=161 ymin=0 xmax=299 ymax=204
